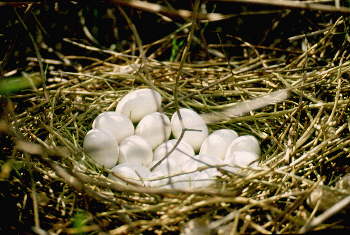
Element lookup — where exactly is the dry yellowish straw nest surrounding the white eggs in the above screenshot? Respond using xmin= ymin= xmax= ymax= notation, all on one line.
xmin=1 ymin=2 xmax=350 ymax=234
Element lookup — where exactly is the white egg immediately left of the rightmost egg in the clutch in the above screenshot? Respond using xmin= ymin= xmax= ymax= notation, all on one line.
xmin=199 ymin=129 xmax=238 ymax=160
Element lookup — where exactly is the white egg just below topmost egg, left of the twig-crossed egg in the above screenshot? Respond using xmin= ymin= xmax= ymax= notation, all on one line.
xmin=135 ymin=112 xmax=171 ymax=149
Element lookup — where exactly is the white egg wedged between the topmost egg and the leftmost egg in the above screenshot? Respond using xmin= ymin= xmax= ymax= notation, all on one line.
xmin=92 ymin=112 xmax=134 ymax=143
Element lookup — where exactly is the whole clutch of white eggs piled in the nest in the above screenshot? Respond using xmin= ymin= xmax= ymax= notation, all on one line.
xmin=83 ymin=88 xmax=261 ymax=190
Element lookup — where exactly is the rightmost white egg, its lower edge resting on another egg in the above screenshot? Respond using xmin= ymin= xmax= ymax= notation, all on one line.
xmin=225 ymin=135 xmax=261 ymax=158
